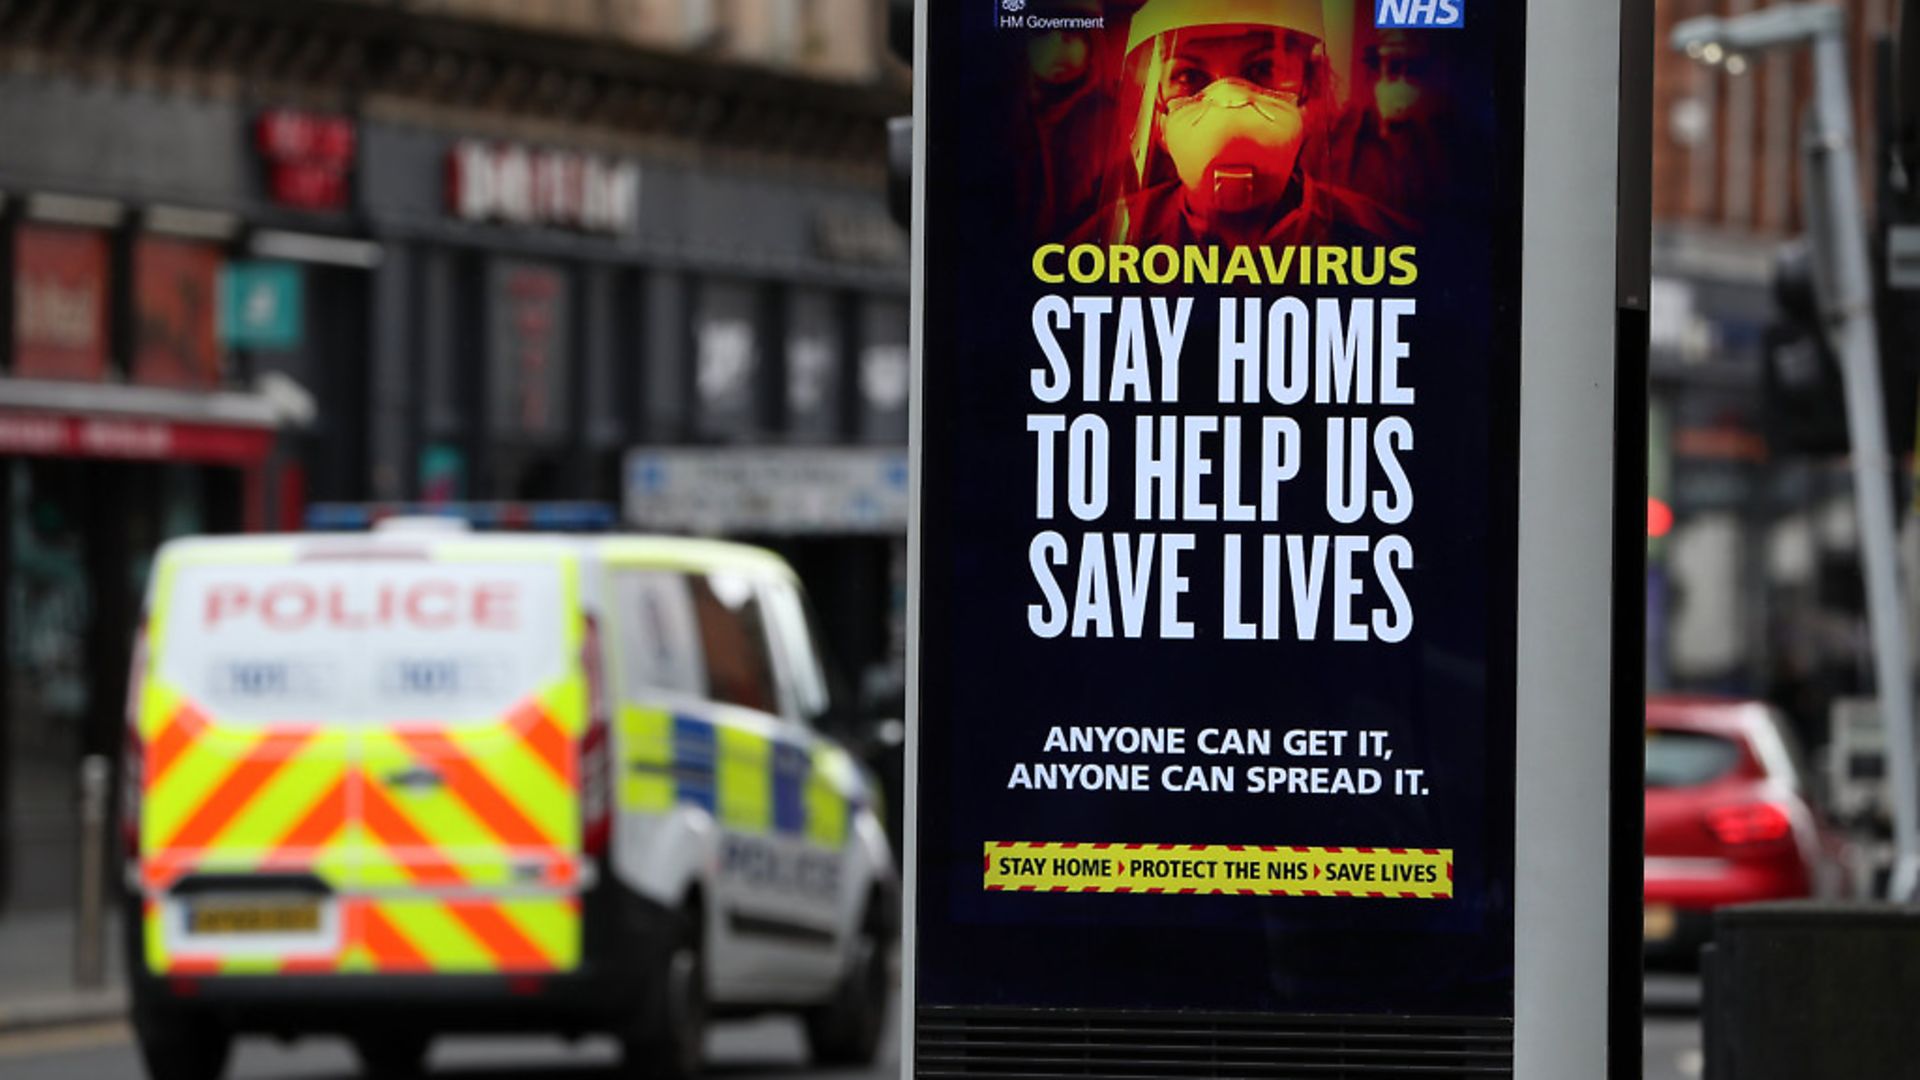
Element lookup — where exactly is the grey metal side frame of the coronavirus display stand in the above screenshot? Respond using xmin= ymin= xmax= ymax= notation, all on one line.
xmin=899 ymin=0 xmax=1651 ymax=1080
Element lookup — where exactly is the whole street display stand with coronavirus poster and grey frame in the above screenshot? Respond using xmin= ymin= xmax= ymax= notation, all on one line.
xmin=906 ymin=0 xmax=1645 ymax=1076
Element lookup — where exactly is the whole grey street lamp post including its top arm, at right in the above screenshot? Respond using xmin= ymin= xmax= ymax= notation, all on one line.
xmin=1672 ymin=4 xmax=1920 ymax=899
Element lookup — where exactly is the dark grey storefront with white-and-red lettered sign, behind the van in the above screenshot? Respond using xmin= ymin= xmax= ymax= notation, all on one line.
xmin=363 ymin=123 xmax=908 ymax=682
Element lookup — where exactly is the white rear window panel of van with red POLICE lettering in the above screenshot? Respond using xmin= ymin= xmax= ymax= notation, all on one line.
xmin=154 ymin=559 xmax=566 ymax=724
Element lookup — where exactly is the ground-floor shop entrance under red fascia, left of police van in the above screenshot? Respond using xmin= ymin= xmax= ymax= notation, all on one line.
xmin=0 ymin=407 xmax=276 ymax=911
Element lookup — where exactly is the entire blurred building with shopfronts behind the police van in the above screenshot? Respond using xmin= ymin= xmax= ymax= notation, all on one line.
xmin=0 ymin=0 xmax=910 ymax=909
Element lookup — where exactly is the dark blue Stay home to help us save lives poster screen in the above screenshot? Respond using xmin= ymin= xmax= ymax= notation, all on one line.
xmin=912 ymin=0 xmax=1528 ymax=1017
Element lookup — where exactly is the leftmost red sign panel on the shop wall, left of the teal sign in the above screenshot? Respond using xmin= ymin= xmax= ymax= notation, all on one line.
xmin=13 ymin=223 xmax=108 ymax=380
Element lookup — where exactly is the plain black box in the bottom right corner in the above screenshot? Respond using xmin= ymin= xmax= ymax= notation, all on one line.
xmin=1703 ymin=901 xmax=1920 ymax=1080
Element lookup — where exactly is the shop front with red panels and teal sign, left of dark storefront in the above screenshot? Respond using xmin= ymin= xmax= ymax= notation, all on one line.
xmin=0 ymin=84 xmax=343 ymax=911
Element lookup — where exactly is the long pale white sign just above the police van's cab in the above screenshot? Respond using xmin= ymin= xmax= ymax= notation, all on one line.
xmin=624 ymin=446 xmax=906 ymax=536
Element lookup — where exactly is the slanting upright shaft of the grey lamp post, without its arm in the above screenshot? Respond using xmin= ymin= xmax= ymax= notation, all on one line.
xmin=1807 ymin=16 xmax=1920 ymax=899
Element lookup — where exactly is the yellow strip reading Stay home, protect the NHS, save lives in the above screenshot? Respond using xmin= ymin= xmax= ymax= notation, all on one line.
xmin=985 ymin=840 xmax=1453 ymax=899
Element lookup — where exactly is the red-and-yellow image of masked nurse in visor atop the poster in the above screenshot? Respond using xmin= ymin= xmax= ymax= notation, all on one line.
xmin=1016 ymin=0 xmax=1486 ymax=244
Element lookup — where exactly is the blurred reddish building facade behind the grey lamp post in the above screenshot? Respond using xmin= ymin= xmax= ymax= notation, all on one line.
xmin=1647 ymin=0 xmax=1912 ymax=742
